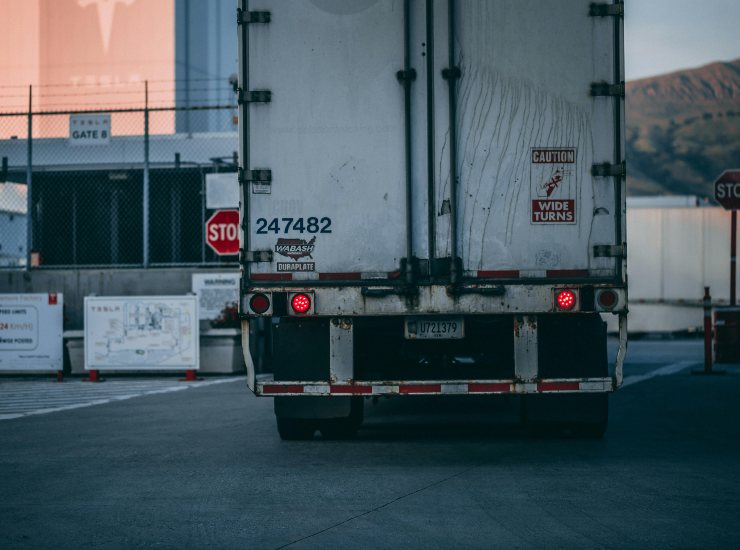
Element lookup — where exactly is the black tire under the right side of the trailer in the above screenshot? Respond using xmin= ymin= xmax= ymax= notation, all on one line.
xmin=522 ymin=393 xmax=609 ymax=439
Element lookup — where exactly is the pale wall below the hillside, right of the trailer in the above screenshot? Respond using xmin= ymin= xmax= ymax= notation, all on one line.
xmin=607 ymin=207 xmax=730 ymax=332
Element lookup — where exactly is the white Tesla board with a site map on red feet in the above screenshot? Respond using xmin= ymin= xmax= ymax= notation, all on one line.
xmin=85 ymin=296 xmax=200 ymax=370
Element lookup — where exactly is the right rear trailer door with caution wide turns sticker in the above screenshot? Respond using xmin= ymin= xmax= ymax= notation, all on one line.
xmin=435 ymin=0 xmax=624 ymax=278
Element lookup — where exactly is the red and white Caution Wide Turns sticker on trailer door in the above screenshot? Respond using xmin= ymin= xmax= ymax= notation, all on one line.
xmin=530 ymin=148 xmax=578 ymax=224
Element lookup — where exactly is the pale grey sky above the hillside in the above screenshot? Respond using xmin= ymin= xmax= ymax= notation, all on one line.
xmin=624 ymin=0 xmax=740 ymax=80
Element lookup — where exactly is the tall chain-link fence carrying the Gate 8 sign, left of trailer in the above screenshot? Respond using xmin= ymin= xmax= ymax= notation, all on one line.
xmin=0 ymin=105 xmax=238 ymax=268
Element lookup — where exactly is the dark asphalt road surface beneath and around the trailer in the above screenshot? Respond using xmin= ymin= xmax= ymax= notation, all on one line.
xmin=0 ymin=341 xmax=740 ymax=549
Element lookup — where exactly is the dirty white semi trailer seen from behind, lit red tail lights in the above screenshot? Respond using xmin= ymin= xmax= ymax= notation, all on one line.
xmin=238 ymin=0 xmax=627 ymax=439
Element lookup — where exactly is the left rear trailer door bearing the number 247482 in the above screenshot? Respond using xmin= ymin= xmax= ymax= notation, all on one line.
xmin=244 ymin=0 xmax=406 ymax=280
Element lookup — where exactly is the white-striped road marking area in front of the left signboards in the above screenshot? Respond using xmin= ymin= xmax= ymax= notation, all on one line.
xmin=0 ymin=376 xmax=244 ymax=420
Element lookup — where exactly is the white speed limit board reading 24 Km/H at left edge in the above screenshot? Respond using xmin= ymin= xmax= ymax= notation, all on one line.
xmin=0 ymin=293 xmax=64 ymax=371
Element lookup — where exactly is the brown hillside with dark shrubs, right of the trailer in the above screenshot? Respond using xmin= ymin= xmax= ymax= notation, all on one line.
xmin=626 ymin=59 xmax=740 ymax=195
